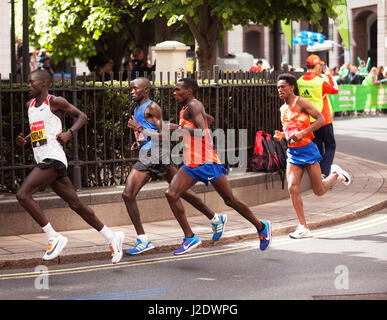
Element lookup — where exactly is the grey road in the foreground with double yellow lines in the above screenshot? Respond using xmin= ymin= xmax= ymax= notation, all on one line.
xmin=0 ymin=209 xmax=387 ymax=300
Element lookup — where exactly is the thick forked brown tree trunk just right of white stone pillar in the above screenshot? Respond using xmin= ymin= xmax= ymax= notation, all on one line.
xmin=185 ymin=0 xmax=222 ymax=76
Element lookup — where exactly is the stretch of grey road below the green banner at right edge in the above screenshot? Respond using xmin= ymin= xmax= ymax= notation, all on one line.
xmin=333 ymin=116 xmax=387 ymax=164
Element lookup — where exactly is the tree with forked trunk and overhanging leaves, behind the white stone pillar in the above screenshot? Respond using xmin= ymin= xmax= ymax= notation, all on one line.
xmin=141 ymin=0 xmax=335 ymax=71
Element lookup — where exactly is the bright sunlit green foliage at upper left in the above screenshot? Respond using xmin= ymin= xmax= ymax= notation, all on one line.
xmin=25 ymin=0 xmax=134 ymax=61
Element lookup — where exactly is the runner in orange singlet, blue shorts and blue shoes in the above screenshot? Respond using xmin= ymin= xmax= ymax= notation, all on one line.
xmin=165 ymin=78 xmax=271 ymax=254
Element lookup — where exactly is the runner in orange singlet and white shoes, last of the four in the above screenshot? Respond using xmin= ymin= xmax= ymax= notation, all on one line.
xmin=274 ymin=73 xmax=351 ymax=238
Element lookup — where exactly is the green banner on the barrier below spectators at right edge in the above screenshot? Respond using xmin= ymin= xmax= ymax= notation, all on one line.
xmin=328 ymin=84 xmax=387 ymax=112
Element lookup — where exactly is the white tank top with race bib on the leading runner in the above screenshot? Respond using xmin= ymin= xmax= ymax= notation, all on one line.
xmin=28 ymin=95 xmax=67 ymax=167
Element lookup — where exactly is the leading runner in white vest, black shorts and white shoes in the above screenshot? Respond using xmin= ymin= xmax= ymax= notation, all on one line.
xmin=16 ymin=70 xmax=124 ymax=263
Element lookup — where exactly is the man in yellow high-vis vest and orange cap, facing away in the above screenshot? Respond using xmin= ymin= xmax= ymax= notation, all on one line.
xmin=297 ymin=54 xmax=339 ymax=179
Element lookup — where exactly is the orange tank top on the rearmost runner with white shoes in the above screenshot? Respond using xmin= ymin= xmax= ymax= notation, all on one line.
xmin=280 ymin=96 xmax=314 ymax=148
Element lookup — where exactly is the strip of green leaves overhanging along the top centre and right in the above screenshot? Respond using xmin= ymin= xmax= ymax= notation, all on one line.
xmin=142 ymin=0 xmax=336 ymax=30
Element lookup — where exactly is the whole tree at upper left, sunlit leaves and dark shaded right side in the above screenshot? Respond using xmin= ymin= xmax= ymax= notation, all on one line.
xmin=32 ymin=0 xmax=174 ymax=72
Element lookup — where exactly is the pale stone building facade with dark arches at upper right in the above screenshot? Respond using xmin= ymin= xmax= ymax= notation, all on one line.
xmin=218 ymin=0 xmax=387 ymax=68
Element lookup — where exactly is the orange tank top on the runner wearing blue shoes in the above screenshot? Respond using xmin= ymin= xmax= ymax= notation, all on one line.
xmin=179 ymin=102 xmax=220 ymax=168
